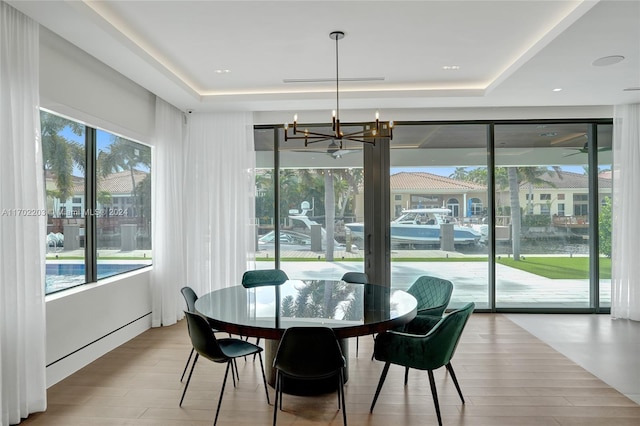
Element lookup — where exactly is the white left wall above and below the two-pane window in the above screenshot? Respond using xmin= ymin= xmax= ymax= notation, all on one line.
xmin=40 ymin=27 xmax=155 ymax=386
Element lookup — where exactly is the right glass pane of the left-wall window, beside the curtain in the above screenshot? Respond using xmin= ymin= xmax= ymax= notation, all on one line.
xmin=95 ymin=130 xmax=151 ymax=279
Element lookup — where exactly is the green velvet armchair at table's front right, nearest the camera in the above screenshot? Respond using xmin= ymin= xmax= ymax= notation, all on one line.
xmin=369 ymin=303 xmax=475 ymax=425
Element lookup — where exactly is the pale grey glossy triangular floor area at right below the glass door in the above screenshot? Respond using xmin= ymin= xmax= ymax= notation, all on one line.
xmin=505 ymin=314 xmax=640 ymax=404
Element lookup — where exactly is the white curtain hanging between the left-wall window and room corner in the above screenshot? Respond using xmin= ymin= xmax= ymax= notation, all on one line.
xmin=151 ymin=98 xmax=186 ymax=327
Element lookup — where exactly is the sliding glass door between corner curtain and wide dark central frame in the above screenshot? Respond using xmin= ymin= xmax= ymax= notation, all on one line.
xmin=256 ymin=128 xmax=363 ymax=279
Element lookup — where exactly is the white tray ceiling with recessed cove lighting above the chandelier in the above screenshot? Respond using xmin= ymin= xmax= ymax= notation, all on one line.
xmin=8 ymin=0 xmax=640 ymax=111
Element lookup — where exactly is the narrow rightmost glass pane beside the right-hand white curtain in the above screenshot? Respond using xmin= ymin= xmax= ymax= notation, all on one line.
xmin=598 ymin=124 xmax=613 ymax=307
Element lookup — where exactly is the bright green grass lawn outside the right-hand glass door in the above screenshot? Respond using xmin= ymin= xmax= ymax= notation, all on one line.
xmin=496 ymin=256 xmax=611 ymax=279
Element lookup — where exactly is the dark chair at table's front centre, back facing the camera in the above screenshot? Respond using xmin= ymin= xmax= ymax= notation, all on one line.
xmin=273 ymin=327 xmax=347 ymax=426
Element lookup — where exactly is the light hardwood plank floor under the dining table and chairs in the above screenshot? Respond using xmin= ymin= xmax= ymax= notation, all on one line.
xmin=21 ymin=313 xmax=640 ymax=426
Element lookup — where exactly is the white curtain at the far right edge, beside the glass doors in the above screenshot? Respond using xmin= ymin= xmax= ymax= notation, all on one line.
xmin=611 ymin=104 xmax=640 ymax=321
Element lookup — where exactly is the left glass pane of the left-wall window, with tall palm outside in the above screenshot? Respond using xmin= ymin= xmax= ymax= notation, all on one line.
xmin=40 ymin=111 xmax=85 ymax=294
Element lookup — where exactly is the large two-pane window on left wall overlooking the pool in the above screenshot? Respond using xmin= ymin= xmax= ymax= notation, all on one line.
xmin=40 ymin=111 xmax=151 ymax=294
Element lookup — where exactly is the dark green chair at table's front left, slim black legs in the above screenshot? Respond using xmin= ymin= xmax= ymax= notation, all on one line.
xmin=180 ymin=311 xmax=270 ymax=426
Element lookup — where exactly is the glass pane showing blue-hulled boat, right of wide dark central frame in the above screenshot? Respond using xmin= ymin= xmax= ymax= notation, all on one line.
xmin=390 ymin=124 xmax=489 ymax=309
